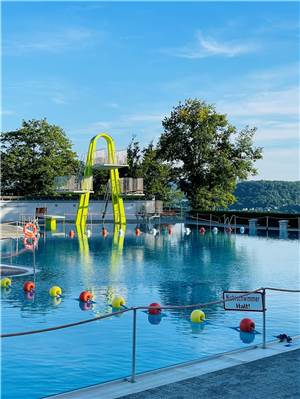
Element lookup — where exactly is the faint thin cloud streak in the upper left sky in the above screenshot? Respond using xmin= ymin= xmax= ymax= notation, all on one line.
xmin=3 ymin=28 xmax=101 ymax=55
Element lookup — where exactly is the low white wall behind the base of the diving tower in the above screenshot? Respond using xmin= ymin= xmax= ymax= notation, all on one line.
xmin=0 ymin=200 xmax=155 ymax=222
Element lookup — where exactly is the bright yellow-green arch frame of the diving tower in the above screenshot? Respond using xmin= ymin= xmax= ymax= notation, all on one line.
xmin=75 ymin=133 xmax=126 ymax=231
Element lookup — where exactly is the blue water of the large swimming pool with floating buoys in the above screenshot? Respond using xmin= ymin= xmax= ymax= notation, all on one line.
xmin=1 ymin=224 xmax=300 ymax=399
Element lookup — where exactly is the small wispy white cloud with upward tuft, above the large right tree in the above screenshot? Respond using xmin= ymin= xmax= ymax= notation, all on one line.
xmin=162 ymin=32 xmax=258 ymax=59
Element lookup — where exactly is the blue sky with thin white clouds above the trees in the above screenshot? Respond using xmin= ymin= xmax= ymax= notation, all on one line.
xmin=2 ymin=2 xmax=299 ymax=180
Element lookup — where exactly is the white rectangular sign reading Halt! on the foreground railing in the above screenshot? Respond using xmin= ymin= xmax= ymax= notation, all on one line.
xmin=223 ymin=291 xmax=264 ymax=312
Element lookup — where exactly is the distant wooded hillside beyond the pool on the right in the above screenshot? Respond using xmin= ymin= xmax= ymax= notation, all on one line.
xmin=230 ymin=180 xmax=300 ymax=213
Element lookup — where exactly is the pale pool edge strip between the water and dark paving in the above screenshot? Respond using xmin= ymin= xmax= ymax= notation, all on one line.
xmin=44 ymin=335 xmax=300 ymax=399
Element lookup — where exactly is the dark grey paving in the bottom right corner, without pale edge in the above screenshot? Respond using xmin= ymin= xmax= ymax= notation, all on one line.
xmin=122 ymin=349 xmax=300 ymax=399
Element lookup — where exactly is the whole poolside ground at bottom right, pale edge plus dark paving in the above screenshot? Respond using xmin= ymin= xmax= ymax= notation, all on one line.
xmin=48 ymin=337 xmax=300 ymax=399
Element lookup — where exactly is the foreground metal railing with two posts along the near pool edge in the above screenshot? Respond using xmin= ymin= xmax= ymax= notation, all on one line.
xmin=0 ymin=287 xmax=300 ymax=382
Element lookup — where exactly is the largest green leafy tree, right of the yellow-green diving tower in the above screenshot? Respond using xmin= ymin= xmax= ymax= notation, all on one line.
xmin=158 ymin=99 xmax=262 ymax=209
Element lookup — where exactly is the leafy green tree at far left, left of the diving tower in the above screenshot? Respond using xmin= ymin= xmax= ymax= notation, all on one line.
xmin=1 ymin=119 xmax=79 ymax=195
